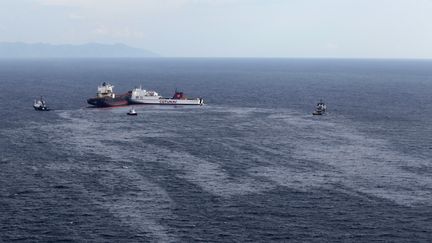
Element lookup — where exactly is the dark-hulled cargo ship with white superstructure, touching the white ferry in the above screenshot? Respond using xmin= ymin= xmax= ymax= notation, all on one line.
xmin=87 ymin=82 xmax=131 ymax=107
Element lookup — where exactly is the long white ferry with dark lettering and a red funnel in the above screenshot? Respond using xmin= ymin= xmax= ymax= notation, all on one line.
xmin=129 ymin=87 xmax=204 ymax=105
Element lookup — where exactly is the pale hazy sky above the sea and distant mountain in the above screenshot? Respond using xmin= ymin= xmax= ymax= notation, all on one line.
xmin=0 ymin=0 xmax=432 ymax=58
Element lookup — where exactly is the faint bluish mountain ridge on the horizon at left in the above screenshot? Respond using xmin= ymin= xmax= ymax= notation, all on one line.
xmin=0 ymin=42 xmax=159 ymax=58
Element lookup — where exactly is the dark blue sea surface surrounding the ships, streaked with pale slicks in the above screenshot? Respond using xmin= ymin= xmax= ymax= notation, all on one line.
xmin=0 ymin=59 xmax=432 ymax=242
